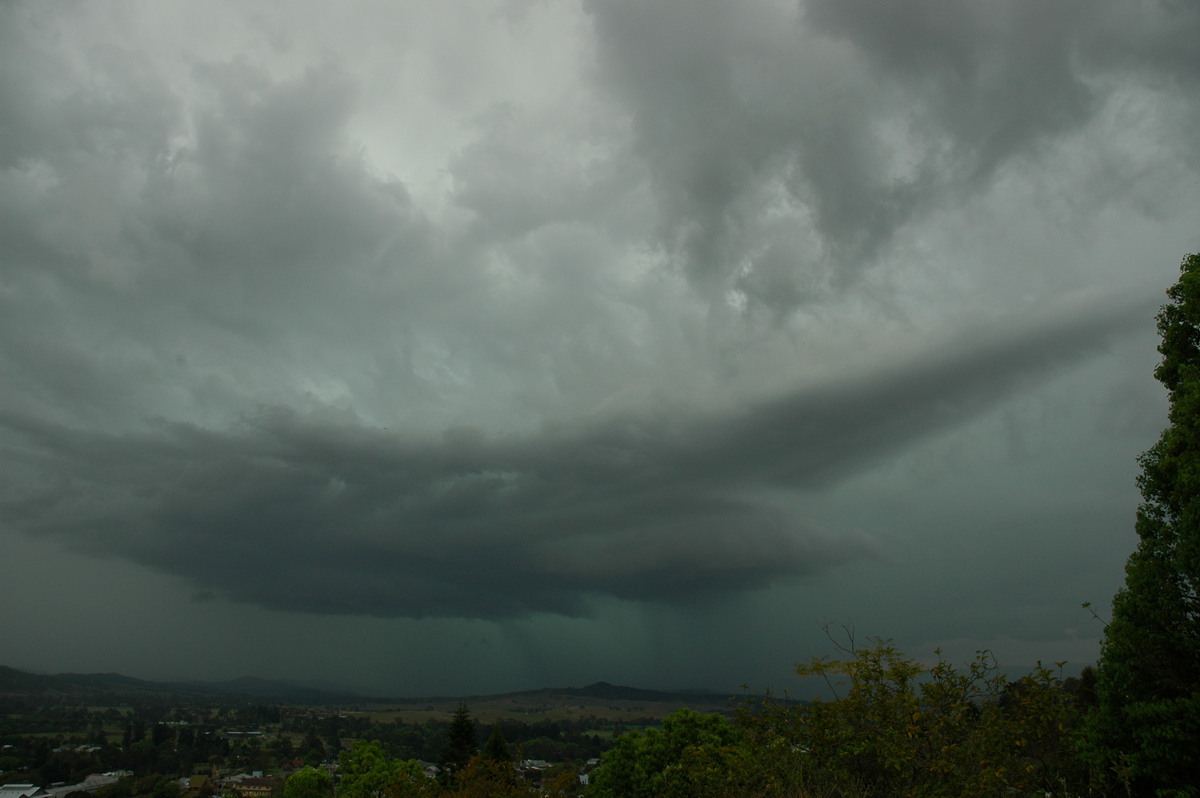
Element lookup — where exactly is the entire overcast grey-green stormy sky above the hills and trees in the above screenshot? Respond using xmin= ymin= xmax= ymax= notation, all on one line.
xmin=0 ymin=0 xmax=1200 ymax=695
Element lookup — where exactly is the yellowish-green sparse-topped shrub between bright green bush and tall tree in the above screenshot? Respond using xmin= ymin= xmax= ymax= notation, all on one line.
xmin=740 ymin=638 xmax=1086 ymax=798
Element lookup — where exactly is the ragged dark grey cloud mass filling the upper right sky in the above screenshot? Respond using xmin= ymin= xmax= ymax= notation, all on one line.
xmin=588 ymin=0 xmax=1200 ymax=312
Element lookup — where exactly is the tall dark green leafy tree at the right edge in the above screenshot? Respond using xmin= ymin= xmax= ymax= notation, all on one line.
xmin=1086 ymin=254 xmax=1200 ymax=797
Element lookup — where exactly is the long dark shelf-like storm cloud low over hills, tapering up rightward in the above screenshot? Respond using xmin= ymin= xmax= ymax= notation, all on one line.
xmin=2 ymin=295 xmax=1146 ymax=618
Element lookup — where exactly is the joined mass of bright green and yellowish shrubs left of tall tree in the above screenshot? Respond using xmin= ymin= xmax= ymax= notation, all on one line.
xmin=589 ymin=641 xmax=1088 ymax=798
